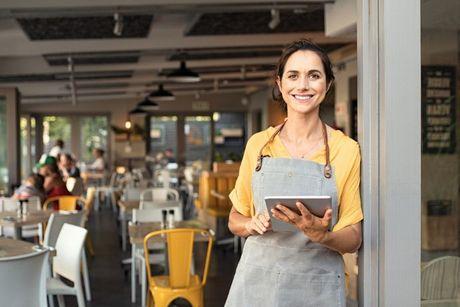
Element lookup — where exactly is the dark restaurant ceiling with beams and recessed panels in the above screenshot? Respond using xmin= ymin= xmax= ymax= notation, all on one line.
xmin=0 ymin=0 xmax=354 ymax=103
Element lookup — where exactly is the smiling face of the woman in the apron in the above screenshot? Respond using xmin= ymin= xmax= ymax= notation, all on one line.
xmin=277 ymin=50 xmax=327 ymax=114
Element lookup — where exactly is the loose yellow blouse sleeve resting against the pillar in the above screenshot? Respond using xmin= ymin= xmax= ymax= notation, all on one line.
xmin=333 ymin=144 xmax=363 ymax=231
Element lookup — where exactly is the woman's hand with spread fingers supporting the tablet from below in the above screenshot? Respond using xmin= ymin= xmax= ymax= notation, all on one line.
xmin=272 ymin=202 xmax=332 ymax=243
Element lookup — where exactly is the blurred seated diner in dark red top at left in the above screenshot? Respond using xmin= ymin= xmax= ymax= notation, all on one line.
xmin=36 ymin=155 xmax=72 ymax=209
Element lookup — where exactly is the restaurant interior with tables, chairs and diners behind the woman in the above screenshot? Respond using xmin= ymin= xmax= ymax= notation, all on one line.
xmin=0 ymin=0 xmax=364 ymax=307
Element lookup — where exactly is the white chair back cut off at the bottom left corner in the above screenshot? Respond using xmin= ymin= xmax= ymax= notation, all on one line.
xmin=0 ymin=249 xmax=49 ymax=307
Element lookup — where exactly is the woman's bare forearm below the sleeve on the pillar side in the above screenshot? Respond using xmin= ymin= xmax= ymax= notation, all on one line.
xmin=321 ymin=223 xmax=362 ymax=254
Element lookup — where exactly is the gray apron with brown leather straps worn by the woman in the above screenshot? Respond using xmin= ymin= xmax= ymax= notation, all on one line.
xmin=225 ymin=124 xmax=345 ymax=307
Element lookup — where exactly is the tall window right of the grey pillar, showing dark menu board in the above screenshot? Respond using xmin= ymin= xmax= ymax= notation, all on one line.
xmin=421 ymin=0 xmax=460 ymax=306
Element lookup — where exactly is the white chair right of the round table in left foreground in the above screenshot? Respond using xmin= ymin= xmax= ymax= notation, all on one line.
xmin=46 ymin=224 xmax=88 ymax=307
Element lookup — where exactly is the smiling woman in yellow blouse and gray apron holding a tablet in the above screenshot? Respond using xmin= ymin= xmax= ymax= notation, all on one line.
xmin=226 ymin=40 xmax=363 ymax=307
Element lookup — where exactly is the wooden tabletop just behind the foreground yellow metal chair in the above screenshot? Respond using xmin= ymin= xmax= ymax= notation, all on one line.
xmin=128 ymin=220 xmax=209 ymax=245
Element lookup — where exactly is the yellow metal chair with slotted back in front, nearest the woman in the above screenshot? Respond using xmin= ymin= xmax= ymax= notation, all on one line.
xmin=144 ymin=228 xmax=213 ymax=307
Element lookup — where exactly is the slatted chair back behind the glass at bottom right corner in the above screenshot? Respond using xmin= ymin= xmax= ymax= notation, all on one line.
xmin=421 ymin=256 xmax=460 ymax=306
